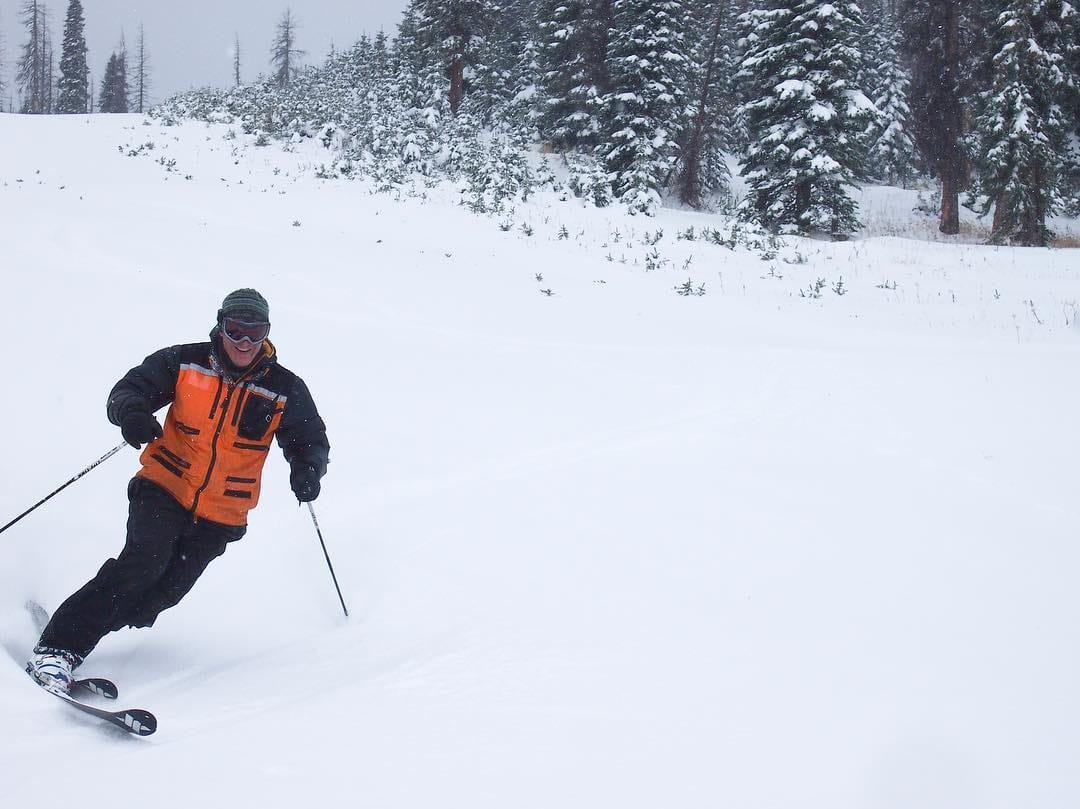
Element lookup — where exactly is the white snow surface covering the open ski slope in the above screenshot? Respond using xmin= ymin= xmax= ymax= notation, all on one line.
xmin=0 ymin=116 xmax=1080 ymax=809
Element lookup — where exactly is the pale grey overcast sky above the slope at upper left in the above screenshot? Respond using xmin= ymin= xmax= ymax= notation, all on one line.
xmin=0 ymin=0 xmax=407 ymax=110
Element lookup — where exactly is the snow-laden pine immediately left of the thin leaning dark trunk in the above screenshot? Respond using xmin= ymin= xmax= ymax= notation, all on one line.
xmin=596 ymin=0 xmax=687 ymax=213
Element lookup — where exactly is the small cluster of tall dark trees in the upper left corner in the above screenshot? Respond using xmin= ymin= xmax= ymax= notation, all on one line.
xmin=0 ymin=0 xmax=150 ymax=114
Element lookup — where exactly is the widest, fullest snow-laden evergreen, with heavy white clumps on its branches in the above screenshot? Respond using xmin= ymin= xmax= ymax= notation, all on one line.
xmin=739 ymin=0 xmax=873 ymax=232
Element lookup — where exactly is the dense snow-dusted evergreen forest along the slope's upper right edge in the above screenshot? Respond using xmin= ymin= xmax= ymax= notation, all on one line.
xmin=164 ymin=0 xmax=1080 ymax=244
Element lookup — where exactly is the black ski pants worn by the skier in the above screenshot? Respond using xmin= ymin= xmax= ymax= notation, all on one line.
xmin=38 ymin=477 xmax=246 ymax=658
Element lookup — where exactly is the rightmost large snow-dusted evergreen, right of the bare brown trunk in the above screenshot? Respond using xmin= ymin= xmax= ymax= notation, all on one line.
xmin=975 ymin=0 xmax=1069 ymax=245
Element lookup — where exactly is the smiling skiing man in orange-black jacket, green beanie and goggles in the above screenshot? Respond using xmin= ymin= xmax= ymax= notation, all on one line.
xmin=26 ymin=289 xmax=329 ymax=691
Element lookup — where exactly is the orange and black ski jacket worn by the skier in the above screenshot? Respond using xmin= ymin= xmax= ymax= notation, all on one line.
xmin=107 ymin=329 xmax=329 ymax=526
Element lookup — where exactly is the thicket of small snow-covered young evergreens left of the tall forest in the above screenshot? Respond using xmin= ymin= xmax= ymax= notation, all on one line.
xmin=151 ymin=41 xmax=550 ymax=212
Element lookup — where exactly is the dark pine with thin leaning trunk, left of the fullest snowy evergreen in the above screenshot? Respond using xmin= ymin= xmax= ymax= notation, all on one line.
xmin=676 ymin=0 xmax=734 ymax=207
